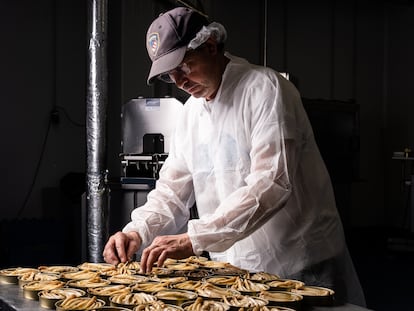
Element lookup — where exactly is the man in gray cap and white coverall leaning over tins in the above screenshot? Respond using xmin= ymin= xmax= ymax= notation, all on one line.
xmin=103 ymin=8 xmax=365 ymax=305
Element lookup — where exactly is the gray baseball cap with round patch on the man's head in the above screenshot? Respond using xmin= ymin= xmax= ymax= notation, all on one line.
xmin=146 ymin=7 xmax=208 ymax=84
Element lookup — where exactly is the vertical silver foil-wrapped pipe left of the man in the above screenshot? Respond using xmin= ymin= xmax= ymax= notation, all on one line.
xmin=86 ymin=0 xmax=108 ymax=262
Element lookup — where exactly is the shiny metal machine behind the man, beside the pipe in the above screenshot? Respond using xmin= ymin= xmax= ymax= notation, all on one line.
xmin=120 ymin=98 xmax=183 ymax=190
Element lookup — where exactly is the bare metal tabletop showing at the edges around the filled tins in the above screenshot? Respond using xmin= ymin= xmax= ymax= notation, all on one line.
xmin=0 ymin=284 xmax=369 ymax=311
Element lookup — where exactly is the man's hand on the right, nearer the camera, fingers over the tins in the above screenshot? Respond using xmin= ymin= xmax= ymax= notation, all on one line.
xmin=140 ymin=233 xmax=194 ymax=273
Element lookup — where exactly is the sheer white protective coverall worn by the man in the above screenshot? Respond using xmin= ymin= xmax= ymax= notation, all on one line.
xmin=123 ymin=53 xmax=365 ymax=306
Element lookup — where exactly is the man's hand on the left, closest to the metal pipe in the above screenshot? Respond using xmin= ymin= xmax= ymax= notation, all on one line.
xmin=103 ymin=231 xmax=142 ymax=265
